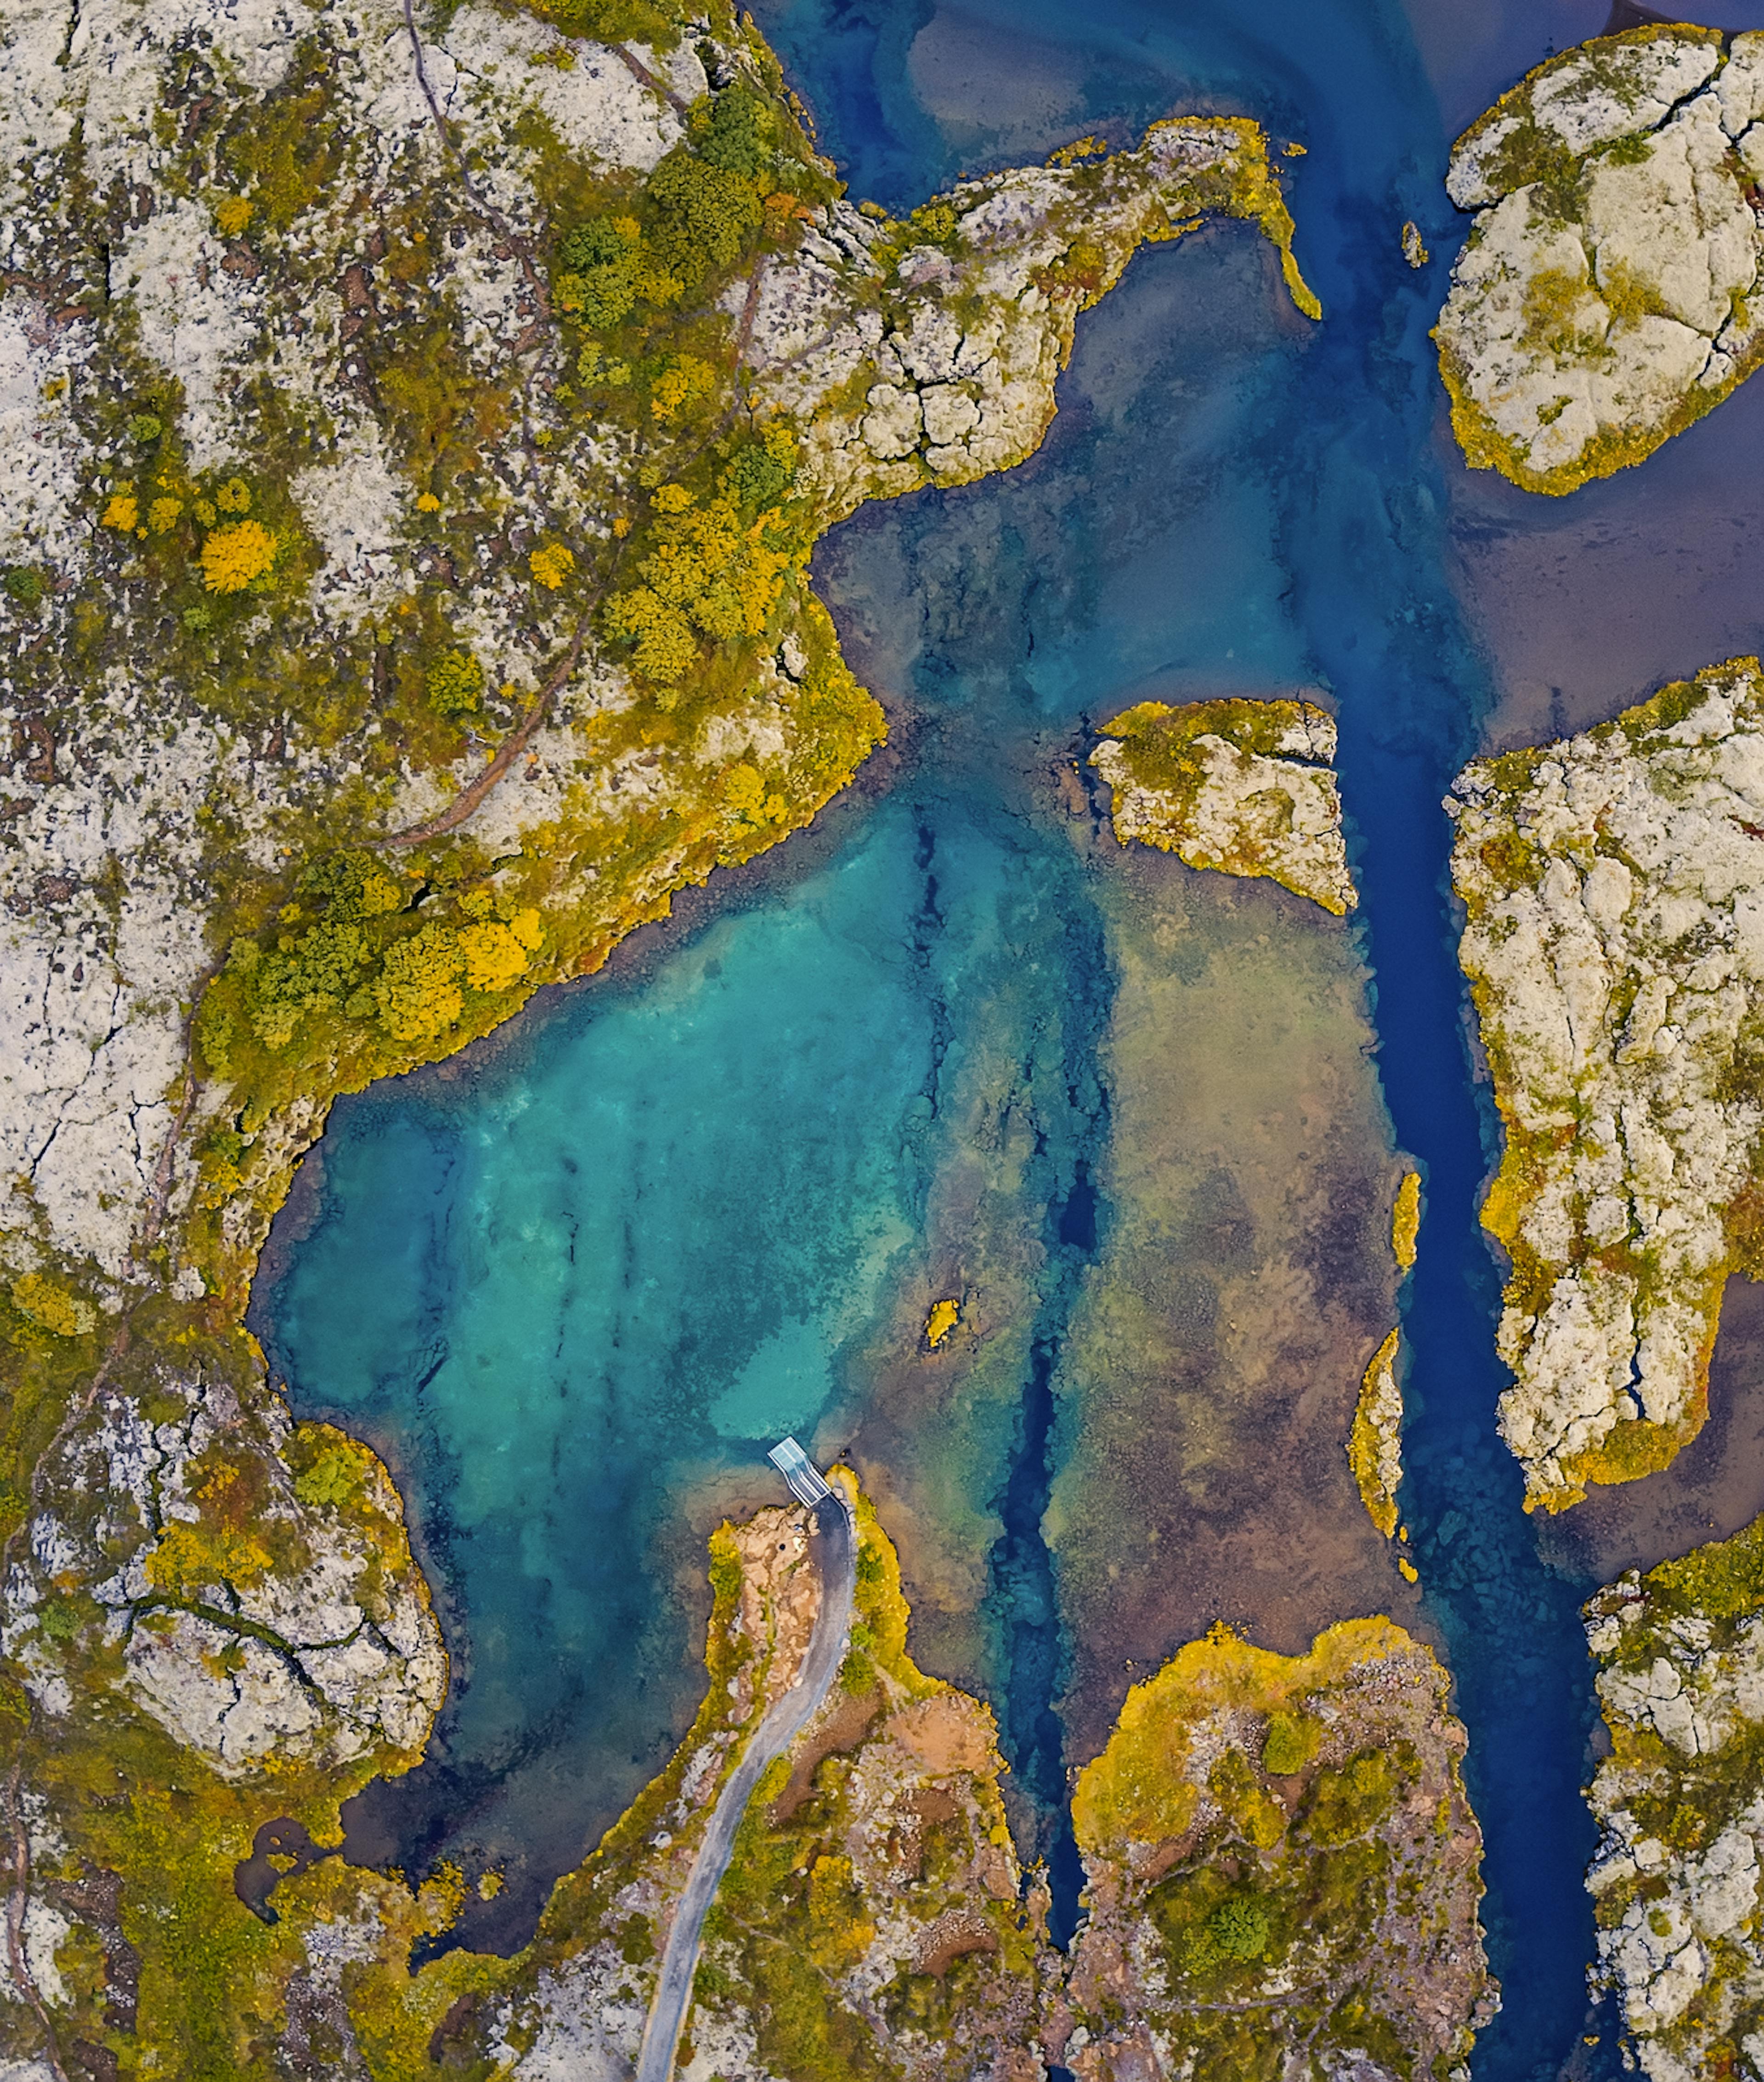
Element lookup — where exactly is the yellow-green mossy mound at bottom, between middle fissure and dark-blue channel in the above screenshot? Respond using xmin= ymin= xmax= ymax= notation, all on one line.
xmin=1066 ymin=1620 xmax=1493 ymax=2082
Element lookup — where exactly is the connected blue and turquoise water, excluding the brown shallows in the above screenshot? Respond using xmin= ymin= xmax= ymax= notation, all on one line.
xmin=258 ymin=0 xmax=1764 ymax=2057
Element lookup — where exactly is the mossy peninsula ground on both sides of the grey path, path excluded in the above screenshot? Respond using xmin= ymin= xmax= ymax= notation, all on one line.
xmin=203 ymin=1474 xmax=1046 ymax=2082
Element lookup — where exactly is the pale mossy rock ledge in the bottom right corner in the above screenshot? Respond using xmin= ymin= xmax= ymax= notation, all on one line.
xmin=1587 ymin=1520 xmax=1764 ymax=2082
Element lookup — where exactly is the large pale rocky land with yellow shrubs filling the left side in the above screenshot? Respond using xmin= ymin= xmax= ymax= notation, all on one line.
xmin=0 ymin=0 xmax=1316 ymax=2078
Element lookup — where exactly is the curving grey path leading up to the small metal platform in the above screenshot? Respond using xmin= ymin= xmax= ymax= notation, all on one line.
xmin=635 ymin=1489 xmax=858 ymax=2082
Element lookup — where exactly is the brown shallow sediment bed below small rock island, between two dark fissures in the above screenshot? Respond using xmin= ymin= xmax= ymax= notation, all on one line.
xmin=1047 ymin=850 xmax=1420 ymax=1761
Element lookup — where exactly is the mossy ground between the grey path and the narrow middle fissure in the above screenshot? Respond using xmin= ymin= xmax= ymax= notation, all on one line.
xmin=698 ymin=1478 xmax=1052 ymax=2082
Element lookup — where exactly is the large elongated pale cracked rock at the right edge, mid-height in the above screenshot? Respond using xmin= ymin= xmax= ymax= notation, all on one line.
xmin=1447 ymin=658 xmax=1764 ymax=1509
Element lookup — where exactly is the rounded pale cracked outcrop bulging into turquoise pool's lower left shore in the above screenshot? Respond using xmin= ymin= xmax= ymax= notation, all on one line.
xmin=0 ymin=1376 xmax=448 ymax=1778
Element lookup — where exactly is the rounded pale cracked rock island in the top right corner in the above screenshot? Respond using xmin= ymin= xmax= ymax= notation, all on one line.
xmin=1435 ymin=25 xmax=1764 ymax=491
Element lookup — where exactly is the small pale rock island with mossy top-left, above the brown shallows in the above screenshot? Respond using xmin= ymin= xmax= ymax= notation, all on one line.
xmin=1091 ymin=699 xmax=1360 ymax=918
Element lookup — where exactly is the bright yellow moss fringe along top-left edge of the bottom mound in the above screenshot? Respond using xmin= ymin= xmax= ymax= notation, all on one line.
xmin=1073 ymin=1618 xmax=1414 ymax=1857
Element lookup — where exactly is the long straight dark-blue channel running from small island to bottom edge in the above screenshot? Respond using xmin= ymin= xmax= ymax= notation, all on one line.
xmin=1341 ymin=741 xmax=1620 ymax=2082
